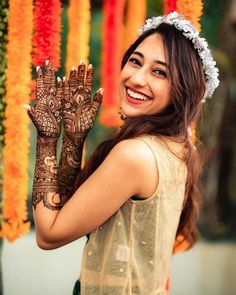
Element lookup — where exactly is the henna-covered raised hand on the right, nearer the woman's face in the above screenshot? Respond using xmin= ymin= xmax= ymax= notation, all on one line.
xmin=62 ymin=63 xmax=102 ymax=139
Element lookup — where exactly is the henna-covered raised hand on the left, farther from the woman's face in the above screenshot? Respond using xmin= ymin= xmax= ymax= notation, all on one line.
xmin=27 ymin=61 xmax=63 ymax=139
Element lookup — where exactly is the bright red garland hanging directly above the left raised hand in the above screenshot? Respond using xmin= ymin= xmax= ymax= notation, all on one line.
xmin=32 ymin=0 xmax=62 ymax=69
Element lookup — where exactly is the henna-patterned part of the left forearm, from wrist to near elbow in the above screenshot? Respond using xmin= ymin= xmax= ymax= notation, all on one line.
xmin=32 ymin=136 xmax=64 ymax=210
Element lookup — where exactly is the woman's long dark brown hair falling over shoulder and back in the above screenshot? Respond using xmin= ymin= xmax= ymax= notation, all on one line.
xmin=76 ymin=24 xmax=205 ymax=248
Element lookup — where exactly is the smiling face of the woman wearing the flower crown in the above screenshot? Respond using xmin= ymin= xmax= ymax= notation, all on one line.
xmin=119 ymin=34 xmax=170 ymax=117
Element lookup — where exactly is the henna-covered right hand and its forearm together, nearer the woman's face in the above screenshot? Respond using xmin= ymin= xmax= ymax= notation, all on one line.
xmin=58 ymin=63 xmax=102 ymax=197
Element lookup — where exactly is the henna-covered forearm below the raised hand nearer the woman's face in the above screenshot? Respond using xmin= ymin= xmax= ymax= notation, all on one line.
xmin=58 ymin=135 xmax=85 ymax=199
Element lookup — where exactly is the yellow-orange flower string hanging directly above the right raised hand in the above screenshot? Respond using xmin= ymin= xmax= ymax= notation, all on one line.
xmin=66 ymin=0 xmax=91 ymax=73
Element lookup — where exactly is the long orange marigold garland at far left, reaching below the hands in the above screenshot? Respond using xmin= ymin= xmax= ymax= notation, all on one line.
xmin=1 ymin=0 xmax=33 ymax=242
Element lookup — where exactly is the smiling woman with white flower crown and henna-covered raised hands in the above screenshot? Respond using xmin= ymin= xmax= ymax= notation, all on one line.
xmin=27 ymin=12 xmax=218 ymax=295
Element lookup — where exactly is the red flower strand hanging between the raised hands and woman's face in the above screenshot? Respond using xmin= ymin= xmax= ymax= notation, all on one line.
xmin=100 ymin=0 xmax=125 ymax=127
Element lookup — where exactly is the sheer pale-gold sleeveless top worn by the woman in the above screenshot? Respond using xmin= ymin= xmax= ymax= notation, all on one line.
xmin=80 ymin=136 xmax=187 ymax=295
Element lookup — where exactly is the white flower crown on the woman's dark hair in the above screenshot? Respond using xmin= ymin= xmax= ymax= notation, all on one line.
xmin=138 ymin=11 xmax=219 ymax=102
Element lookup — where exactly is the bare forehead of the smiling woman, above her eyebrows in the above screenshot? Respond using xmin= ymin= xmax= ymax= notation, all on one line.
xmin=135 ymin=33 xmax=166 ymax=61
